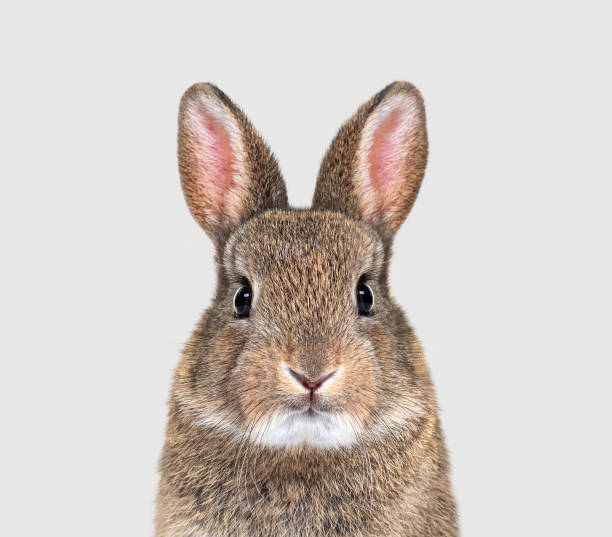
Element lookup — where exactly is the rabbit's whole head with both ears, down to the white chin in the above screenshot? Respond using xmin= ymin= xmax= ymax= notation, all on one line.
xmin=173 ymin=82 xmax=435 ymax=448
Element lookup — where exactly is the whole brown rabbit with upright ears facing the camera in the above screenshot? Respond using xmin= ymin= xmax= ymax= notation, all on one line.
xmin=155 ymin=82 xmax=459 ymax=537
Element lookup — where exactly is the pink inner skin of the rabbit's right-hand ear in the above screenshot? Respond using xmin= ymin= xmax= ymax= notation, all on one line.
xmin=368 ymin=108 xmax=409 ymax=212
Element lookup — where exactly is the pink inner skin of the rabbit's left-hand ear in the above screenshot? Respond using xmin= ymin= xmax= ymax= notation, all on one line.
xmin=195 ymin=106 xmax=237 ymax=215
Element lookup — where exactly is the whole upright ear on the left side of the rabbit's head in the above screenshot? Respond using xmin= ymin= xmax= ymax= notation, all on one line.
xmin=178 ymin=84 xmax=287 ymax=245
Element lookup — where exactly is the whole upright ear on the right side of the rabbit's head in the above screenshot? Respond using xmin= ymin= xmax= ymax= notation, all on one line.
xmin=312 ymin=82 xmax=427 ymax=239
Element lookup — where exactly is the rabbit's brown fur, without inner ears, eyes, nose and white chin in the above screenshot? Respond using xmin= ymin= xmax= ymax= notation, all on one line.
xmin=156 ymin=83 xmax=458 ymax=537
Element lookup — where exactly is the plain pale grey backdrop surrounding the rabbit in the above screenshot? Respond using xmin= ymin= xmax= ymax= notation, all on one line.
xmin=0 ymin=1 xmax=612 ymax=537
